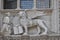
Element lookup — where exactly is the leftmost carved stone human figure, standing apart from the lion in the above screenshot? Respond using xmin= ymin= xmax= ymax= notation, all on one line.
xmin=1 ymin=12 xmax=11 ymax=35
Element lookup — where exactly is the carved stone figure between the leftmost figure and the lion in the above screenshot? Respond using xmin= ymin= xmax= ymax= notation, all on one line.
xmin=12 ymin=14 xmax=23 ymax=34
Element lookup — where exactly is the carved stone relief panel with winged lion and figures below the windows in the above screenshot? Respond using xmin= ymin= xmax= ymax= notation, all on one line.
xmin=0 ymin=11 xmax=57 ymax=36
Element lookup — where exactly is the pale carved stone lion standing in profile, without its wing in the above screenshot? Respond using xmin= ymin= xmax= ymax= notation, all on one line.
xmin=18 ymin=12 xmax=47 ymax=35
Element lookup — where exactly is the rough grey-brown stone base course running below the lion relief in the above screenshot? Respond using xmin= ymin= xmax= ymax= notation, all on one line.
xmin=0 ymin=35 xmax=60 ymax=40
